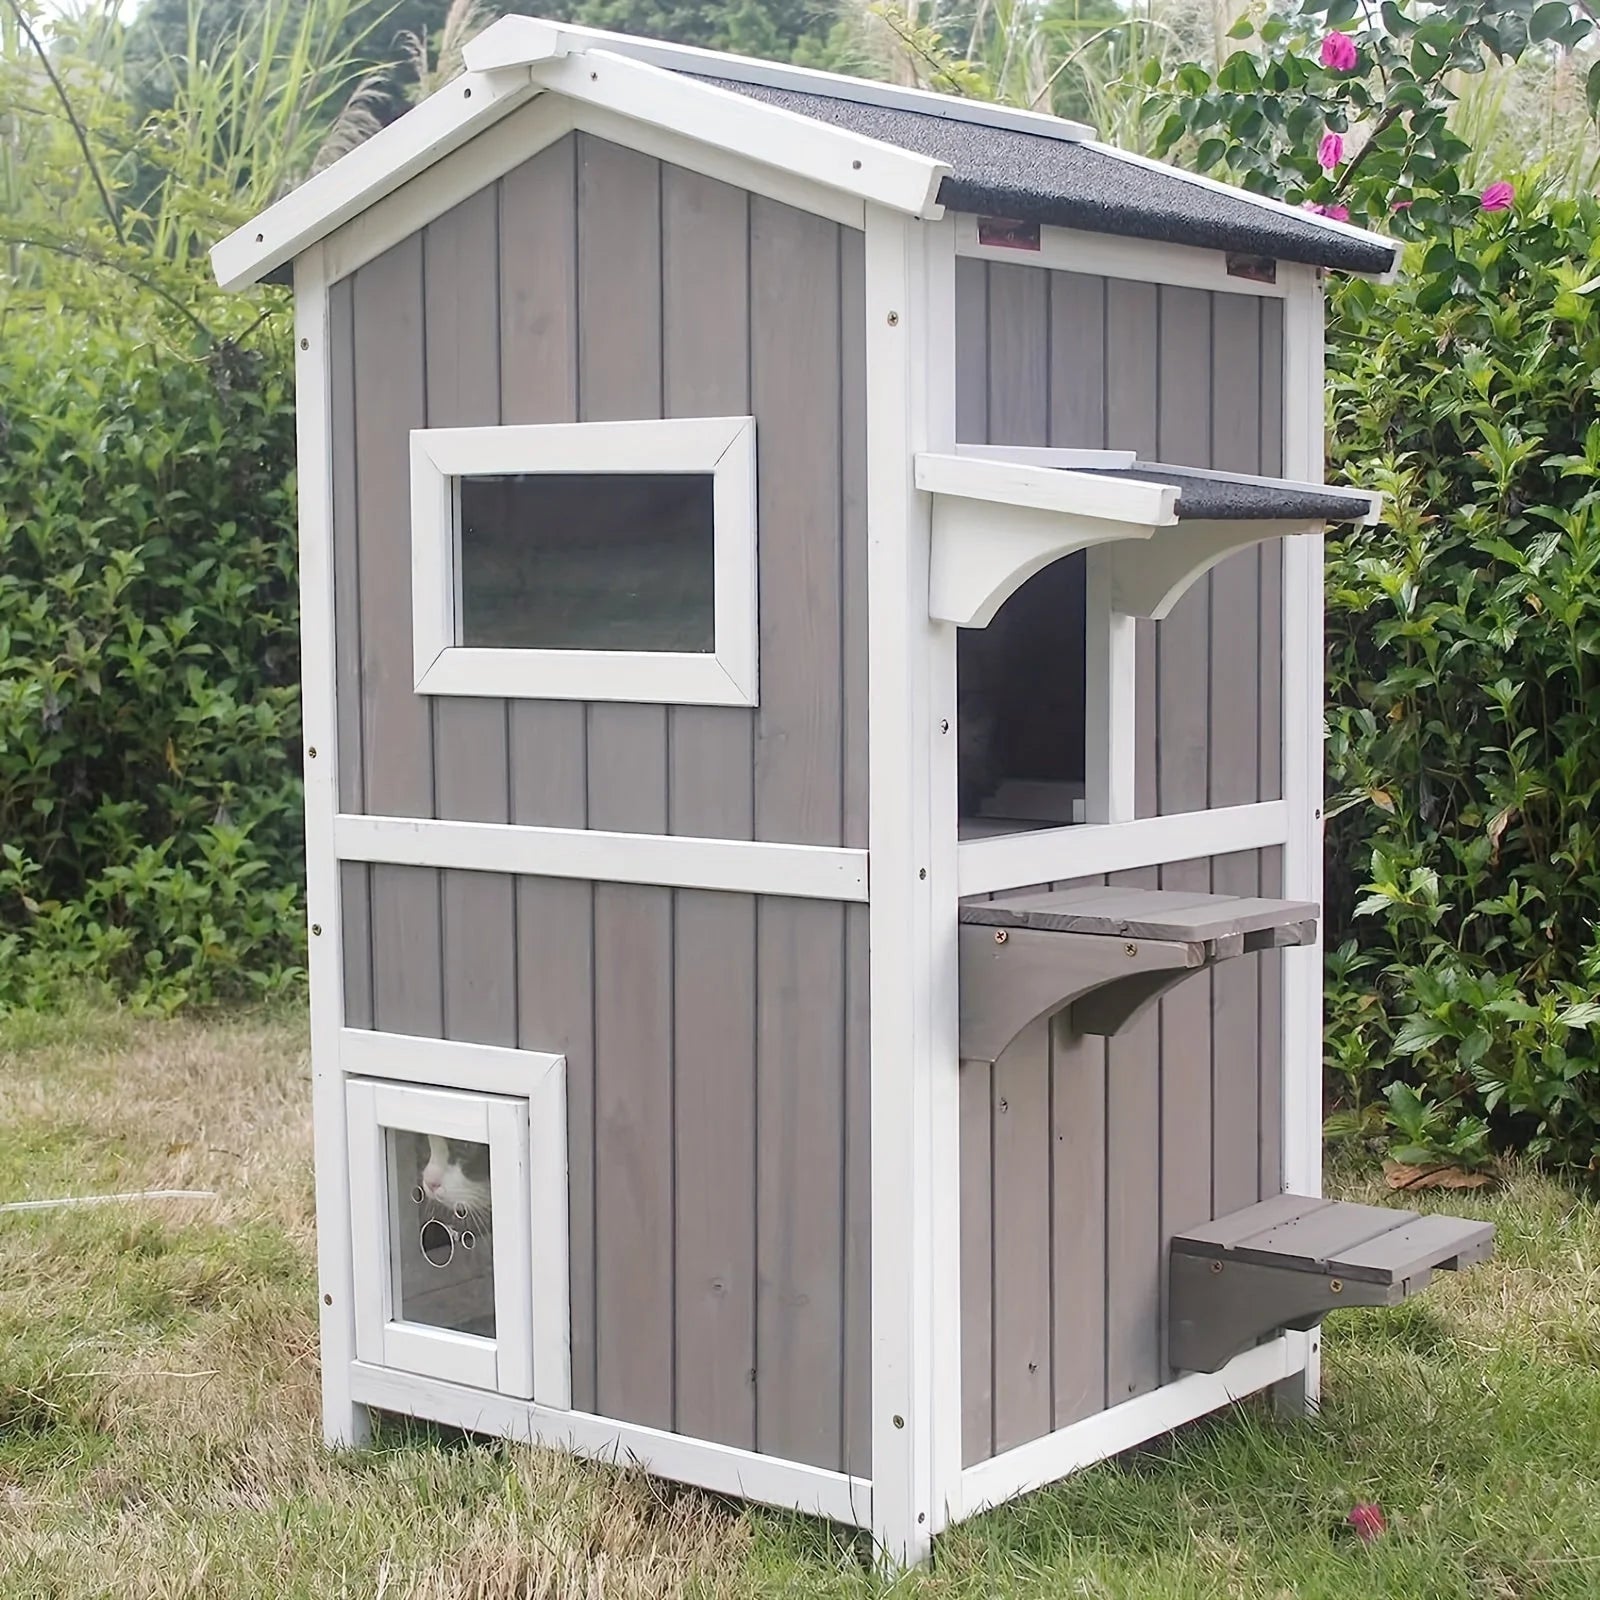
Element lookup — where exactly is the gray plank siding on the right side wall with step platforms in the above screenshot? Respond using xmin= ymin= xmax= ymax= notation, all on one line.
xmin=957 ymin=259 xmax=1283 ymax=1462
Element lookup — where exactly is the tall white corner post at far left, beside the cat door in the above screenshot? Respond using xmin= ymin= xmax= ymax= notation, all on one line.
xmin=294 ymin=245 xmax=371 ymax=1445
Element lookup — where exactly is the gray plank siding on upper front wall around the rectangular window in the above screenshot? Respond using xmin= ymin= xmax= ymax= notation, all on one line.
xmin=333 ymin=134 xmax=867 ymax=857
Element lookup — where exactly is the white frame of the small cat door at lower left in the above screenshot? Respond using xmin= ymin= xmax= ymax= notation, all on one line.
xmin=339 ymin=1027 xmax=571 ymax=1410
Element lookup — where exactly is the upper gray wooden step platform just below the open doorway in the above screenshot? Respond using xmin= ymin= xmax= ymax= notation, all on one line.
xmin=960 ymin=888 xmax=1317 ymax=1061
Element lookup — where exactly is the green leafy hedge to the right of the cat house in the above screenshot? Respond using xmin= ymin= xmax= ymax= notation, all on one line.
xmin=1328 ymin=198 xmax=1600 ymax=1168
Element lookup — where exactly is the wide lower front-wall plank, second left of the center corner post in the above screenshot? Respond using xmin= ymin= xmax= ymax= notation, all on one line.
xmin=755 ymin=899 xmax=845 ymax=1469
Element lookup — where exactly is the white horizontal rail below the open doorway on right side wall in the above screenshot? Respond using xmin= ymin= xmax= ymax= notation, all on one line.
xmin=957 ymin=797 xmax=1292 ymax=899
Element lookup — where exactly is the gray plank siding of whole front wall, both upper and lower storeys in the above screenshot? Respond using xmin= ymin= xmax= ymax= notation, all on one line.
xmin=333 ymin=134 xmax=870 ymax=1474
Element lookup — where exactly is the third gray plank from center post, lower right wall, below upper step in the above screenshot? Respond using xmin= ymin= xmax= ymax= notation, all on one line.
xmin=1050 ymin=1018 xmax=1107 ymax=1427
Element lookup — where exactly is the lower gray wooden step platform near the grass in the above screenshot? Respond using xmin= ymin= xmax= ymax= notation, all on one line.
xmin=1166 ymin=1195 xmax=1494 ymax=1373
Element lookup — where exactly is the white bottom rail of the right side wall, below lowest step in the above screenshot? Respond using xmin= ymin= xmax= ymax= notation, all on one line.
xmin=962 ymin=1338 xmax=1294 ymax=1517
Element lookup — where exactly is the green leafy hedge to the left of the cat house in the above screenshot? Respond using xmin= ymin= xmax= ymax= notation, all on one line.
xmin=0 ymin=315 xmax=304 ymax=1006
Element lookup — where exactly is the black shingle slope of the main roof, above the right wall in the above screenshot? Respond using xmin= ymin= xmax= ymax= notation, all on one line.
xmin=704 ymin=78 xmax=1395 ymax=274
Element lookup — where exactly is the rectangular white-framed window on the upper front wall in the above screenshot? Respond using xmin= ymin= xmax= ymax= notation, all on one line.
xmin=411 ymin=416 xmax=757 ymax=706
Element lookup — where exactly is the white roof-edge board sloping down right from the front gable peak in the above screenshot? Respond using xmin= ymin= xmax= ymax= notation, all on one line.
xmin=534 ymin=48 xmax=950 ymax=218
